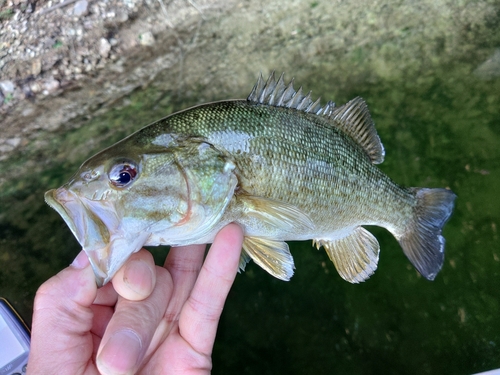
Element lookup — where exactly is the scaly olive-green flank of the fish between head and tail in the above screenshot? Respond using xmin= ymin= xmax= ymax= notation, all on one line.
xmin=151 ymin=101 xmax=406 ymax=234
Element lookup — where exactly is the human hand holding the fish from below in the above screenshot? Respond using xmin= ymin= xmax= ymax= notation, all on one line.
xmin=28 ymin=224 xmax=243 ymax=375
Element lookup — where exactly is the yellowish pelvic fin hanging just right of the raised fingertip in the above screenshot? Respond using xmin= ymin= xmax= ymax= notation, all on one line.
xmin=240 ymin=237 xmax=295 ymax=281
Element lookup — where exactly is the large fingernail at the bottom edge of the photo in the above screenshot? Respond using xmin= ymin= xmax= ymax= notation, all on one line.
xmin=97 ymin=329 xmax=142 ymax=374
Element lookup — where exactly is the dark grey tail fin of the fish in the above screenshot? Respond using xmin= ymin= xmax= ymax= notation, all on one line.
xmin=398 ymin=188 xmax=456 ymax=280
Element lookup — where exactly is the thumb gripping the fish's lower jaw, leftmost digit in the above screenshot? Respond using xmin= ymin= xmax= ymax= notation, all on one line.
xmin=29 ymin=251 xmax=97 ymax=374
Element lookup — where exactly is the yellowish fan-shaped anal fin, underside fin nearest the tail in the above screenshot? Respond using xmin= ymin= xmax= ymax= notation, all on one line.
xmin=313 ymin=227 xmax=380 ymax=284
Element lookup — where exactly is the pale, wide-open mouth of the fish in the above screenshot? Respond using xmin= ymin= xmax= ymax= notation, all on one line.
xmin=45 ymin=187 xmax=114 ymax=287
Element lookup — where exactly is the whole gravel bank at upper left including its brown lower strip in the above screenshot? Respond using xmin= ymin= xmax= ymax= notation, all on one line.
xmin=0 ymin=0 xmax=223 ymax=161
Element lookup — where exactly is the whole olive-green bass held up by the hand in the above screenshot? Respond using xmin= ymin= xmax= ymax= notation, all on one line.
xmin=45 ymin=72 xmax=456 ymax=286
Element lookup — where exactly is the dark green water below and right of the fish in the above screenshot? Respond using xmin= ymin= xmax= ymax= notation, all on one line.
xmin=215 ymin=70 xmax=500 ymax=374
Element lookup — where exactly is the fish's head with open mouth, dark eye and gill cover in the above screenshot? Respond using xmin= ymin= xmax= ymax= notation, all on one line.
xmin=45 ymin=137 xmax=236 ymax=286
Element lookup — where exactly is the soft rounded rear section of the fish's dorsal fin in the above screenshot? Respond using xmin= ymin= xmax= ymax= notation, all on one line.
xmin=329 ymin=96 xmax=385 ymax=164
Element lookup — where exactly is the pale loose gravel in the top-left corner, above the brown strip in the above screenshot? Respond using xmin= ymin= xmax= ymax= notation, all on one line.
xmin=0 ymin=0 xmax=145 ymax=106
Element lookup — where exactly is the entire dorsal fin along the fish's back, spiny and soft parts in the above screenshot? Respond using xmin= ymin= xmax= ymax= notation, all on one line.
xmin=247 ymin=72 xmax=385 ymax=164
